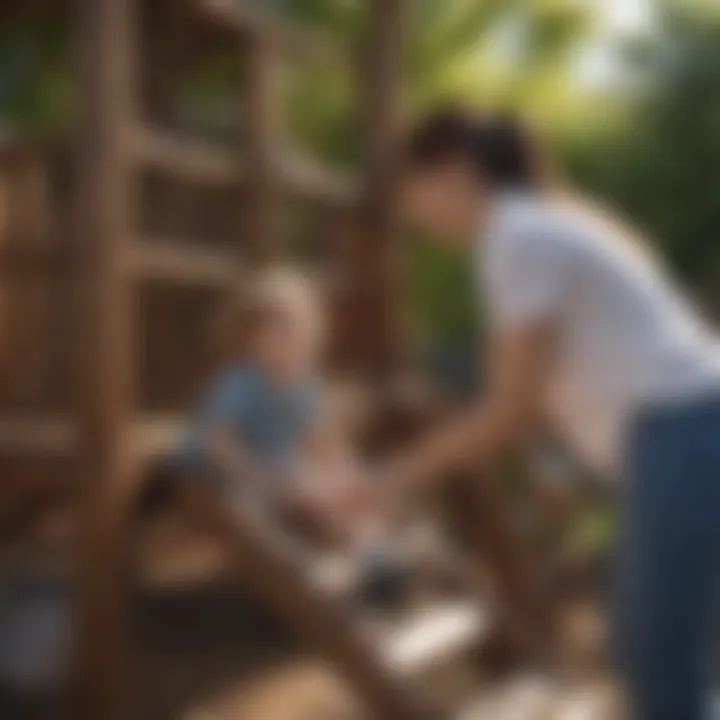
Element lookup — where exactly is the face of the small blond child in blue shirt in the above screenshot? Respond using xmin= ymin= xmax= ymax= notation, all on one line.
xmin=253 ymin=315 xmax=320 ymax=378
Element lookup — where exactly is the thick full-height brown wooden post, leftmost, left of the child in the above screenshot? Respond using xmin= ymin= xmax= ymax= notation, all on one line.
xmin=73 ymin=0 xmax=136 ymax=720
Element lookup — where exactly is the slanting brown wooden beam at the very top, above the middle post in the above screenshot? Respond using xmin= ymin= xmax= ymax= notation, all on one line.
xmin=196 ymin=0 xmax=347 ymax=62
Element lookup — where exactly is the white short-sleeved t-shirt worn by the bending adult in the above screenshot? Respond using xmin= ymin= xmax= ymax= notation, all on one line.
xmin=478 ymin=195 xmax=720 ymax=469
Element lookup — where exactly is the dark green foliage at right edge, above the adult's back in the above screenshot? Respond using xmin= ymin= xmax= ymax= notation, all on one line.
xmin=566 ymin=5 xmax=720 ymax=293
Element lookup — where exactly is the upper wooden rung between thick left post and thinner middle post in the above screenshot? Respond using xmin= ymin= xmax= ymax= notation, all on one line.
xmin=131 ymin=127 xmax=242 ymax=185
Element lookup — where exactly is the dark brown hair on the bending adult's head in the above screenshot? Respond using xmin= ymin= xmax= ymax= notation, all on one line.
xmin=404 ymin=107 xmax=547 ymax=190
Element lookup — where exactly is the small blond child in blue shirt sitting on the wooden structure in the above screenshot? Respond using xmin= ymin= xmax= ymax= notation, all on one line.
xmin=178 ymin=271 xmax=400 ymax=580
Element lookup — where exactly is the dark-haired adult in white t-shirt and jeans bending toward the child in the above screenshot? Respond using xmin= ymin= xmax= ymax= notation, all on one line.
xmin=391 ymin=104 xmax=720 ymax=720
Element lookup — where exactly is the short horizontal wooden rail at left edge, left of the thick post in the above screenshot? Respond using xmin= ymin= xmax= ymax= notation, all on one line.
xmin=0 ymin=417 xmax=79 ymax=455
